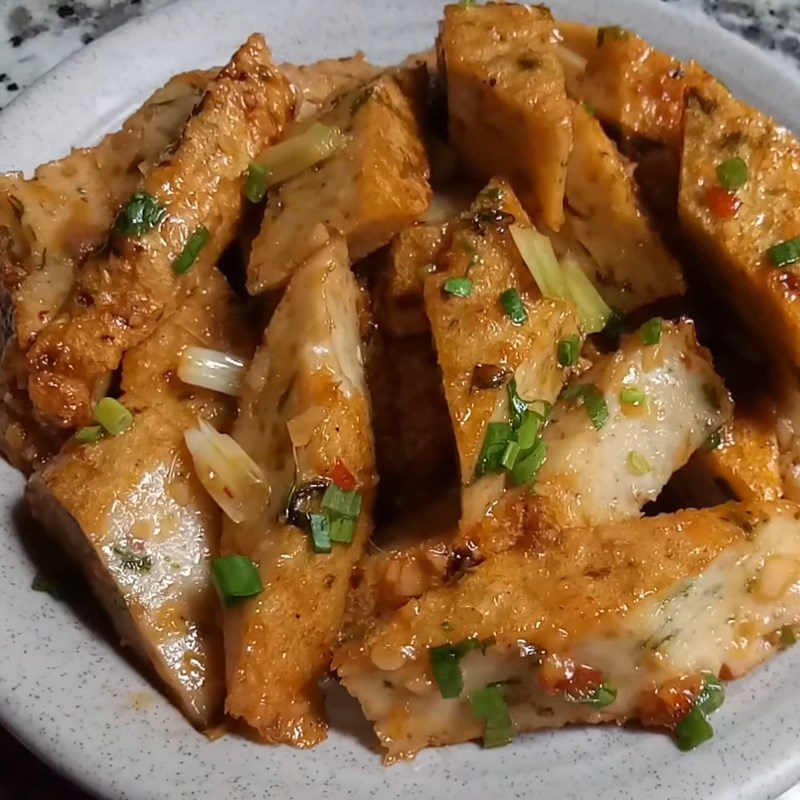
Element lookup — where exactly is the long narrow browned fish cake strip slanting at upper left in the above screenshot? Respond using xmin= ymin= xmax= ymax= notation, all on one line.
xmin=28 ymin=35 xmax=294 ymax=428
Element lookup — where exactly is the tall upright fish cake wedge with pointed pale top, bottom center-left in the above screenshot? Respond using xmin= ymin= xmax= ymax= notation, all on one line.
xmin=222 ymin=235 xmax=377 ymax=747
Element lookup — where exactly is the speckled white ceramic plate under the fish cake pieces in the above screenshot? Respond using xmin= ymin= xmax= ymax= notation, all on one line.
xmin=0 ymin=0 xmax=800 ymax=800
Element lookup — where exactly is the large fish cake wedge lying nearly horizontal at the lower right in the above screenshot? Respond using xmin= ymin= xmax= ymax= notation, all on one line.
xmin=335 ymin=501 xmax=800 ymax=762
